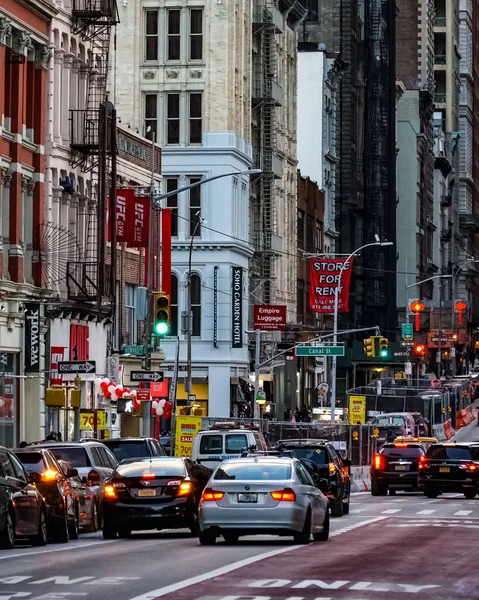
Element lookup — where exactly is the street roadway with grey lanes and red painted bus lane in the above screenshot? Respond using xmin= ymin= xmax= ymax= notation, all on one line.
xmin=0 ymin=493 xmax=479 ymax=600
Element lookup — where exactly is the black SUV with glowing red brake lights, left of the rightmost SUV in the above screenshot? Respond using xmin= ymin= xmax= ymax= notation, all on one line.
xmin=371 ymin=442 xmax=426 ymax=496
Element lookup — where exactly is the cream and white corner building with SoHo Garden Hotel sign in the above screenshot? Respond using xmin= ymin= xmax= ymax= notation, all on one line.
xmin=109 ymin=0 xmax=252 ymax=416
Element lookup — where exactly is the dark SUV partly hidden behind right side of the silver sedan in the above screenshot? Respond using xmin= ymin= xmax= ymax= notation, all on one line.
xmin=277 ymin=440 xmax=351 ymax=517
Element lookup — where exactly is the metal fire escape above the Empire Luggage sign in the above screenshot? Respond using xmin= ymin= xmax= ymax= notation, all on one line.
xmin=251 ymin=0 xmax=283 ymax=304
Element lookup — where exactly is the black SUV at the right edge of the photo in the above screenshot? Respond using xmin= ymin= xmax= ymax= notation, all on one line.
xmin=419 ymin=442 xmax=479 ymax=500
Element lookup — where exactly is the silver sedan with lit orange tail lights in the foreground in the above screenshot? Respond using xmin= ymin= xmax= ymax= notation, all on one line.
xmin=199 ymin=456 xmax=329 ymax=545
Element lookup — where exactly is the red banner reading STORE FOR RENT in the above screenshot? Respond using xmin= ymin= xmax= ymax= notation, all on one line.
xmin=309 ymin=258 xmax=353 ymax=313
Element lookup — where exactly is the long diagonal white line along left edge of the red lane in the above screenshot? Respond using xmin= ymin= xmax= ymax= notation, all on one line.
xmin=130 ymin=517 xmax=387 ymax=600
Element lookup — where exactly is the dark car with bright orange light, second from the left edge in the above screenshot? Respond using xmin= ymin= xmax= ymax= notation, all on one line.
xmin=15 ymin=446 xmax=80 ymax=543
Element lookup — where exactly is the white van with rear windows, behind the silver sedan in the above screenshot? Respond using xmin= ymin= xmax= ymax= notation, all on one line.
xmin=191 ymin=424 xmax=268 ymax=469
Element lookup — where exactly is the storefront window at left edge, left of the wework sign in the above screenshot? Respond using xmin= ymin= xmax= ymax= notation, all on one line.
xmin=0 ymin=352 xmax=18 ymax=448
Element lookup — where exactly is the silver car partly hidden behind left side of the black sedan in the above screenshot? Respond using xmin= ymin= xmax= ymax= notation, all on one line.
xmin=35 ymin=442 xmax=118 ymax=525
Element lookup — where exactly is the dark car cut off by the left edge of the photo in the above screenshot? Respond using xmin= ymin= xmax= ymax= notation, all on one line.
xmin=0 ymin=447 xmax=48 ymax=548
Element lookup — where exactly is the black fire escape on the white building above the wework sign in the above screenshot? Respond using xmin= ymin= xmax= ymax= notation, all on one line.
xmin=67 ymin=0 xmax=119 ymax=313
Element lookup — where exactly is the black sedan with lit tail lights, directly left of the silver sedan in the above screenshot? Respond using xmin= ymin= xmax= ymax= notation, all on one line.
xmin=103 ymin=457 xmax=204 ymax=539
